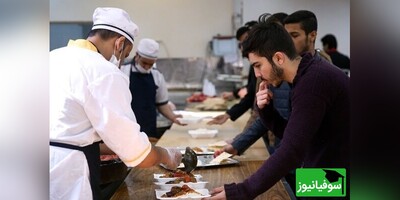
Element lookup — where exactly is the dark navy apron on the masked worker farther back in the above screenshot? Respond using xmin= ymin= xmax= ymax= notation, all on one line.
xmin=129 ymin=66 xmax=160 ymax=138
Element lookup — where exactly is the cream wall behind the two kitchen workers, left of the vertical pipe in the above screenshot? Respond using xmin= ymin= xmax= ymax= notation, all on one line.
xmin=50 ymin=0 xmax=233 ymax=58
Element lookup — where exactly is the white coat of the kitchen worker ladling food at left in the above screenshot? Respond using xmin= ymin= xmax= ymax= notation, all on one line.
xmin=50 ymin=40 xmax=151 ymax=199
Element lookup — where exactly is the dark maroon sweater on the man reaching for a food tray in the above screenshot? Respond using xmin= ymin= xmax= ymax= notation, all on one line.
xmin=224 ymin=54 xmax=350 ymax=200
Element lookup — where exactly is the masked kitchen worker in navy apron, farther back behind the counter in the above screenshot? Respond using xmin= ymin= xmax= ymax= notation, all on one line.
xmin=121 ymin=38 xmax=182 ymax=141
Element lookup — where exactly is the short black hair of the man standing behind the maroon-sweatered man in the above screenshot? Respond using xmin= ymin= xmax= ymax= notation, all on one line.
xmin=284 ymin=10 xmax=318 ymax=35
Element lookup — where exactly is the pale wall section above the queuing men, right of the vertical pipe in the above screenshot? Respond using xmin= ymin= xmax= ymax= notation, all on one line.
xmin=243 ymin=0 xmax=350 ymax=56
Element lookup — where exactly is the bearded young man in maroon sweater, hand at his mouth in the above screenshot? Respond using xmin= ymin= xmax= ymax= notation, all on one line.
xmin=208 ymin=19 xmax=350 ymax=200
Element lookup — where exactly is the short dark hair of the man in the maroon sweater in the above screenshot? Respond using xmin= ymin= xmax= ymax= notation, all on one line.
xmin=243 ymin=22 xmax=297 ymax=63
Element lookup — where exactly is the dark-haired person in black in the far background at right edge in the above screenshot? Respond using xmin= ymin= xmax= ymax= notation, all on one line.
xmin=321 ymin=34 xmax=350 ymax=70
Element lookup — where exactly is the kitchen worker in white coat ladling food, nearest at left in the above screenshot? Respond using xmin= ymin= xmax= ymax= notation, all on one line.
xmin=50 ymin=8 xmax=181 ymax=199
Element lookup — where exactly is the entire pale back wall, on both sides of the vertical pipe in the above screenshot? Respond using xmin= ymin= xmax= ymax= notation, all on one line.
xmin=50 ymin=0 xmax=350 ymax=58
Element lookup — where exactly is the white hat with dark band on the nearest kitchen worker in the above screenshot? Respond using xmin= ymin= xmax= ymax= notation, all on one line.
xmin=92 ymin=8 xmax=139 ymax=44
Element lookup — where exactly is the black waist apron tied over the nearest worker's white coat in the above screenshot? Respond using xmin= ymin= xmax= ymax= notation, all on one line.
xmin=50 ymin=142 xmax=101 ymax=200
